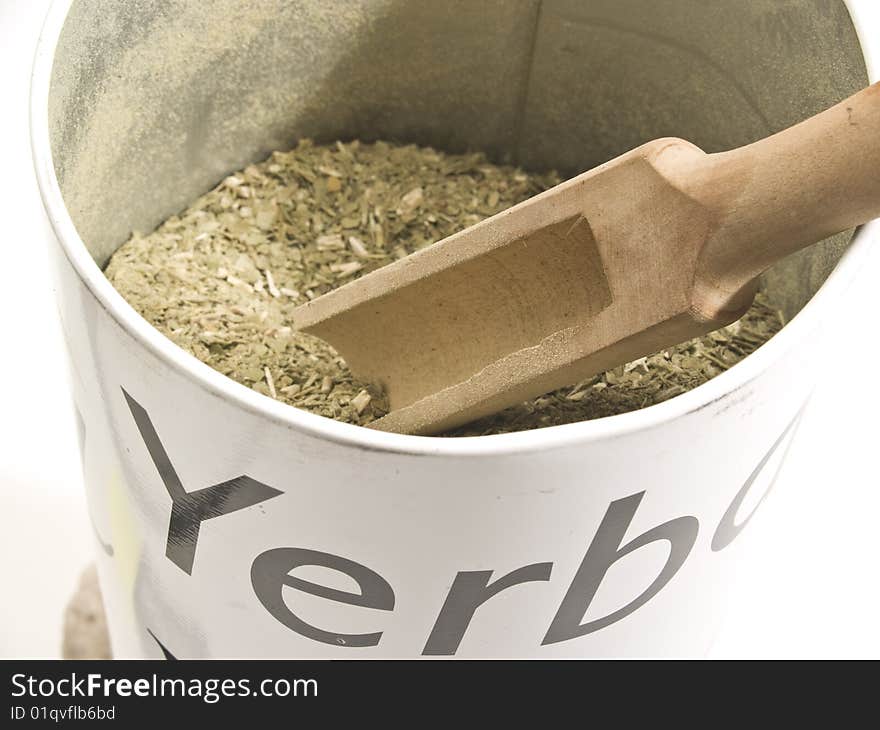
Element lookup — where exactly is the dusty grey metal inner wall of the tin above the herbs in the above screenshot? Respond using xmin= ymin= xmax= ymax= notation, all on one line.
xmin=49 ymin=0 xmax=867 ymax=316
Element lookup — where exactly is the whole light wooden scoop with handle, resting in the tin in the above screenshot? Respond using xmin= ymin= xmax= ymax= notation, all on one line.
xmin=294 ymin=84 xmax=880 ymax=434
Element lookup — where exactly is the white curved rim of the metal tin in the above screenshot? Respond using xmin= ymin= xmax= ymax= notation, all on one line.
xmin=30 ymin=0 xmax=880 ymax=457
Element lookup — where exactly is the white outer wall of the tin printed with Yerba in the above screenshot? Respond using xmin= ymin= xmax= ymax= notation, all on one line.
xmin=54 ymin=236 xmax=821 ymax=658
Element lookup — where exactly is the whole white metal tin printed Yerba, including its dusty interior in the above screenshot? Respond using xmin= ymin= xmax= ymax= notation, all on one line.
xmin=34 ymin=0 xmax=870 ymax=658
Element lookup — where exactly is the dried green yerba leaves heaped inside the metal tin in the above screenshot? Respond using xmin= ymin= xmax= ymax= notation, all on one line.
xmin=106 ymin=140 xmax=782 ymax=435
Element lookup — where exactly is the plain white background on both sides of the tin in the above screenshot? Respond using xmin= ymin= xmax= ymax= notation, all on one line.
xmin=0 ymin=0 xmax=880 ymax=658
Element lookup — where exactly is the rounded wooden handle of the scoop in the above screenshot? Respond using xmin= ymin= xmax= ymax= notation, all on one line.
xmin=688 ymin=82 xmax=880 ymax=298
